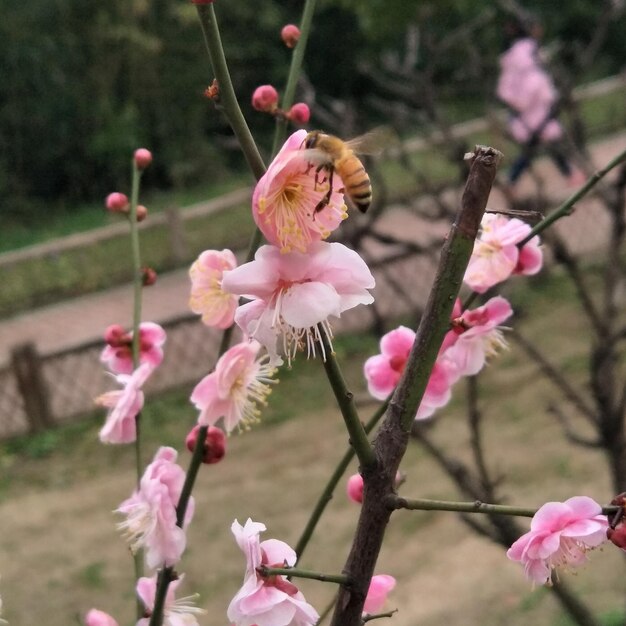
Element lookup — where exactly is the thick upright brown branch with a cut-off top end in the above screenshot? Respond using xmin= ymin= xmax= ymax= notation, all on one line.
xmin=331 ymin=146 xmax=500 ymax=626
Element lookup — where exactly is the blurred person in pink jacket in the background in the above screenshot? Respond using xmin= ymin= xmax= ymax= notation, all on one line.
xmin=496 ymin=23 xmax=582 ymax=186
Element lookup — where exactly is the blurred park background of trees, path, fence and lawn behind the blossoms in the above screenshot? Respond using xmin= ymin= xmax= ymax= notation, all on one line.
xmin=0 ymin=0 xmax=626 ymax=626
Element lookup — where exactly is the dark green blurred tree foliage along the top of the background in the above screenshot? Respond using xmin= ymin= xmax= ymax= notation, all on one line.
xmin=0 ymin=0 xmax=625 ymax=225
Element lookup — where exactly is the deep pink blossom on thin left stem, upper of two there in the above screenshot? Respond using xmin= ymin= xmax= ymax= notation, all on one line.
xmin=100 ymin=322 xmax=167 ymax=374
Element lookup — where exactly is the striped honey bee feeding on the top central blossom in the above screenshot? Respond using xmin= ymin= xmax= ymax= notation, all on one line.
xmin=302 ymin=130 xmax=386 ymax=213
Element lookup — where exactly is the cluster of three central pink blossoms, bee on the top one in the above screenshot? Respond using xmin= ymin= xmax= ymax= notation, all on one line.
xmin=190 ymin=130 xmax=374 ymax=370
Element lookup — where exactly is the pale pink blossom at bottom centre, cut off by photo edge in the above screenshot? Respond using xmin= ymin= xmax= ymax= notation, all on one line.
xmin=227 ymin=519 xmax=319 ymax=626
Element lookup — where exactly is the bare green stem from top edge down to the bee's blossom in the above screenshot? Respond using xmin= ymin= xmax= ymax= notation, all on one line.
xmin=196 ymin=3 xmax=265 ymax=180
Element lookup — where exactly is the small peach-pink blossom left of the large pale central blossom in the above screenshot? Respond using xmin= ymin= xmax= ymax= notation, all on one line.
xmin=189 ymin=248 xmax=237 ymax=328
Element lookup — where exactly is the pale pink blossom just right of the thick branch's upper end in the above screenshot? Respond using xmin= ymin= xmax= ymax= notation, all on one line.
xmin=463 ymin=213 xmax=543 ymax=293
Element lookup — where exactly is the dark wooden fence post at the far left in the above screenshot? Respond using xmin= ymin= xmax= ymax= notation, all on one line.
xmin=11 ymin=342 xmax=54 ymax=433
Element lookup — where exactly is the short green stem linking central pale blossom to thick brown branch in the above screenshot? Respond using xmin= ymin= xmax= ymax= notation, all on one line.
xmin=318 ymin=324 xmax=376 ymax=467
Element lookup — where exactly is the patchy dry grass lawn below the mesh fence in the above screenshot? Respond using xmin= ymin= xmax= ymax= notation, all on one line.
xmin=0 ymin=256 xmax=623 ymax=626
